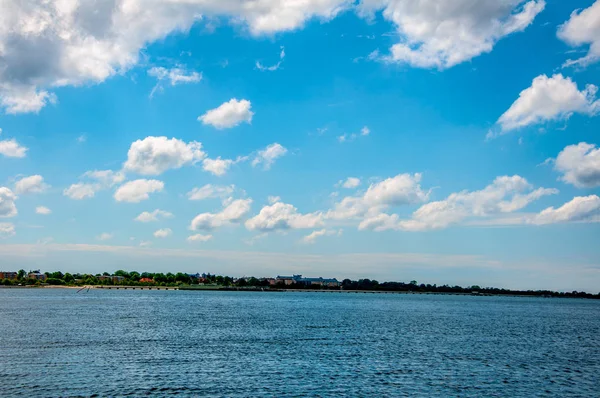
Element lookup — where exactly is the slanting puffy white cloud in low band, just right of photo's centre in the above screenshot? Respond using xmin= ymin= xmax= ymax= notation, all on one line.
xmin=327 ymin=173 xmax=429 ymax=220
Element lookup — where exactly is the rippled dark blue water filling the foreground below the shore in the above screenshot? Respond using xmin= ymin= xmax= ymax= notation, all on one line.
xmin=0 ymin=289 xmax=600 ymax=397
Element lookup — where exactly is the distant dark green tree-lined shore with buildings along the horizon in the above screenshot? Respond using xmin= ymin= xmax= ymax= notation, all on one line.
xmin=0 ymin=270 xmax=600 ymax=299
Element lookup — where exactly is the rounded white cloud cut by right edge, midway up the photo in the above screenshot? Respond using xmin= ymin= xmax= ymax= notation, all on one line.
xmin=554 ymin=142 xmax=600 ymax=188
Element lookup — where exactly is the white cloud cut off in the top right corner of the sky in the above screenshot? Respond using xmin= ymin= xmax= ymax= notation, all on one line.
xmin=558 ymin=0 xmax=600 ymax=67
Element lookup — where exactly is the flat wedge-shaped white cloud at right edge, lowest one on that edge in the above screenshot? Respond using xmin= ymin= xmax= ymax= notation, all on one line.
xmin=528 ymin=195 xmax=600 ymax=225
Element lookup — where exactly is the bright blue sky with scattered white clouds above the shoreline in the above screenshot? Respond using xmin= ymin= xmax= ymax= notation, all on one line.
xmin=0 ymin=0 xmax=600 ymax=293
